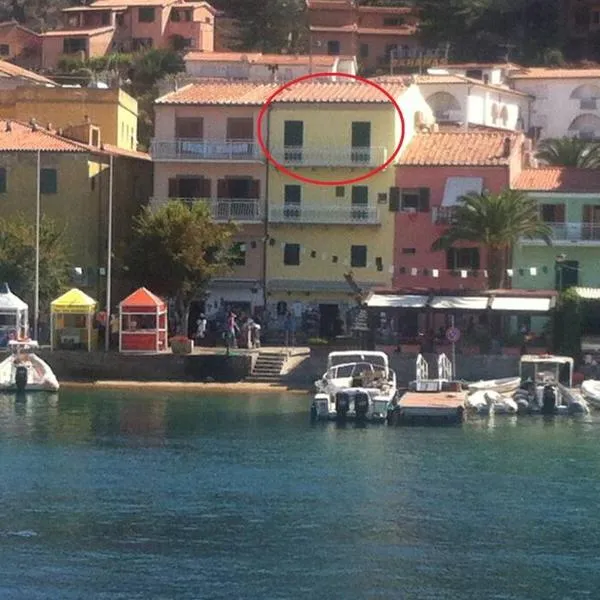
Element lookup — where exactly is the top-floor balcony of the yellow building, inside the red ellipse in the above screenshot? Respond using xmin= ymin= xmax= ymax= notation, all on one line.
xmin=271 ymin=146 xmax=387 ymax=168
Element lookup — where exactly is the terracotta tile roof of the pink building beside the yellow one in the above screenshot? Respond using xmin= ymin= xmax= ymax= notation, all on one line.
xmin=398 ymin=131 xmax=523 ymax=167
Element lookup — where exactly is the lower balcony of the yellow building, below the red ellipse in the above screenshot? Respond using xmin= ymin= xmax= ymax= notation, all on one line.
xmin=269 ymin=205 xmax=381 ymax=225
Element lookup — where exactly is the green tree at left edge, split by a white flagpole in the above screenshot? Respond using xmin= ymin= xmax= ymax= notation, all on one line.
xmin=0 ymin=214 xmax=71 ymax=307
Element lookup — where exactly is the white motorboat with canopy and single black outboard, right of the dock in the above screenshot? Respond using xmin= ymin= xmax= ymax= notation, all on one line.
xmin=515 ymin=354 xmax=590 ymax=415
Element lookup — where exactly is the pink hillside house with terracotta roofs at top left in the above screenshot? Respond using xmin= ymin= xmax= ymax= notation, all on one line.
xmin=42 ymin=0 xmax=216 ymax=69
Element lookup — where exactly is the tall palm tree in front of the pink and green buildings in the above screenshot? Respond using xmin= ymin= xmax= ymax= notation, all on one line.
xmin=431 ymin=189 xmax=552 ymax=289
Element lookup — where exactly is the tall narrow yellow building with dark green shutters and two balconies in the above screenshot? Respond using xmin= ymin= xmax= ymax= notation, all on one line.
xmin=267 ymin=80 xmax=429 ymax=337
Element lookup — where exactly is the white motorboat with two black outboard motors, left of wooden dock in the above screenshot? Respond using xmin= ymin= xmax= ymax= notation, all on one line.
xmin=311 ymin=350 xmax=398 ymax=421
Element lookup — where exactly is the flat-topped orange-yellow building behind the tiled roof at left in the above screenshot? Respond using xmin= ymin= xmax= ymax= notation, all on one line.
xmin=0 ymin=86 xmax=138 ymax=150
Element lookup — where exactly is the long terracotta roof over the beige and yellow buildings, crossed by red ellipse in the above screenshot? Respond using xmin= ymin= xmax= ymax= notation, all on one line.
xmin=156 ymin=81 xmax=405 ymax=106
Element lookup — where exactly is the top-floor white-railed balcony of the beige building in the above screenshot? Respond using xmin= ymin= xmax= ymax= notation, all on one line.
xmin=150 ymin=138 xmax=263 ymax=162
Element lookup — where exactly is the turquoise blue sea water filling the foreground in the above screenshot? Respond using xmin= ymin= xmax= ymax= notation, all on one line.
xmin=0 ymin=390 xmax=600 ymax=600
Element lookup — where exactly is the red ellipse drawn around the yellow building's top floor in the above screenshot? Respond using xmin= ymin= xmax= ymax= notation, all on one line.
xmin=256 ymin=73 xmax=405 ymax=185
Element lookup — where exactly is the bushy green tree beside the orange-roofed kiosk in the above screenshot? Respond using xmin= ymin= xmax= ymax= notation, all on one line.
xmin=123 ymin=201 xmax=237 ymax=333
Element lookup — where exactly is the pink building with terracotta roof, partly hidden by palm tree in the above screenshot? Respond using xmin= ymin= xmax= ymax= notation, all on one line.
xmin=390 ymin=129 xmax=525 ymax=290
